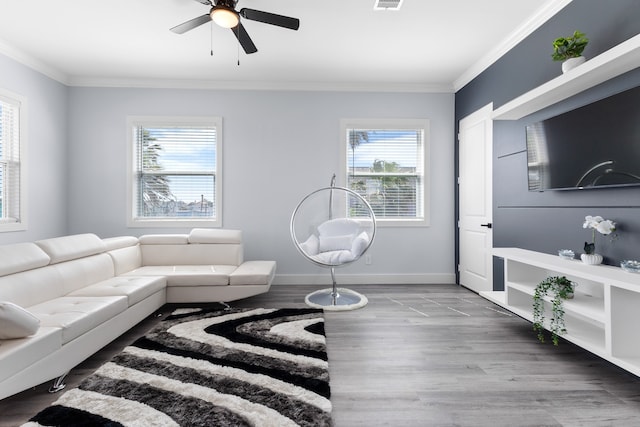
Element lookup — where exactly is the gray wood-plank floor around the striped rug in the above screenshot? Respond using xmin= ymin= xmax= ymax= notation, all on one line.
xmin=0 ymin=285 xmax=640 ymax=427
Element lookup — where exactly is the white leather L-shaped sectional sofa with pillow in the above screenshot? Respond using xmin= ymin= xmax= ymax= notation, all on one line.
xmin=0 ymin=229 xmax=276 ymax=399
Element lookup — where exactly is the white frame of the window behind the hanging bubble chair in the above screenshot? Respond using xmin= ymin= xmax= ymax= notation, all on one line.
xmin=338 ymin=119 xmax=431 ymax=227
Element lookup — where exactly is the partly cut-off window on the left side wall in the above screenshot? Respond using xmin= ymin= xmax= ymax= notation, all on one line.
xmin=0 ymin=90 xmax=27 ymax=231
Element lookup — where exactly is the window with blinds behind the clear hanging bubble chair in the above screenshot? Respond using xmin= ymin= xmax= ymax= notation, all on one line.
xmin=341 ymin=120 xmax=429 ymax=225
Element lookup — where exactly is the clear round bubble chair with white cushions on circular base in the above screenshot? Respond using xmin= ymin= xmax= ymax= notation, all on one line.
xmin=290 ymin=175 xmax=376 ymax=311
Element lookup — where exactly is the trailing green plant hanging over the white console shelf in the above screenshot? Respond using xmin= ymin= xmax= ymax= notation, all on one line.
xmin=533 ymin=276 xmax=576 ymax=345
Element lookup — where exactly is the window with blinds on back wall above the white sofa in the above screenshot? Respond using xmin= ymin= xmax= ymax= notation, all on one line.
xmin=128 ymin=113 xmax=222 ymax=227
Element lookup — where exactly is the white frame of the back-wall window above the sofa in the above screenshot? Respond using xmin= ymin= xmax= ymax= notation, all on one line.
xmin=127 ymin=116 xmax=223 ymax=228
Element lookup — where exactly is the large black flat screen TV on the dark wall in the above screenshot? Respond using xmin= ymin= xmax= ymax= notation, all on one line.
xmin=526 ymin=86 xmax=640 ymax=191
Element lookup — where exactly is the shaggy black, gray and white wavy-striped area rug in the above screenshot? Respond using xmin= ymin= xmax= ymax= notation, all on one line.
xmin=25 ymin=308 xmax=331 ymax=427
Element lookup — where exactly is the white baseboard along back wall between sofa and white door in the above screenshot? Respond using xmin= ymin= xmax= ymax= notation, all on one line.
xmin=273 ymin=270 xmax=456 ymax=286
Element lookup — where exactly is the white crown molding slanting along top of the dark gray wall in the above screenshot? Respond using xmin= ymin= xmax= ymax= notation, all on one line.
xmin=453 ymin=0 xmax=573 ymax=92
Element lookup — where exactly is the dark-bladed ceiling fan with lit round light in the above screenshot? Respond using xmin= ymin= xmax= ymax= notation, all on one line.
xmin=171 ymin=0 xmax=300 ymax=54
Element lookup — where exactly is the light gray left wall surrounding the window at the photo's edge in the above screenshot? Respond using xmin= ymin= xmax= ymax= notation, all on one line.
xmin=0 ymin=55 xmax=68 ymax=244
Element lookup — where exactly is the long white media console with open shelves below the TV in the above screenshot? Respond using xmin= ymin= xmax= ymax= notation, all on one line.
xmin=480 ymin=248 xmax=640 ymax=376
